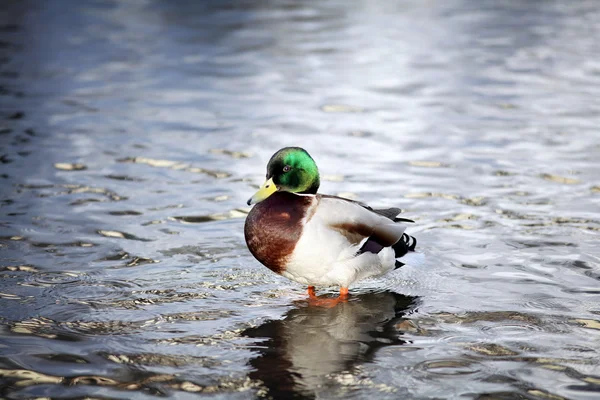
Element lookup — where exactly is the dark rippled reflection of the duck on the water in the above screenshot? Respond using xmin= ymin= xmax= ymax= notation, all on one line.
xmin=243 ymin=292 xmax=417 ymax=399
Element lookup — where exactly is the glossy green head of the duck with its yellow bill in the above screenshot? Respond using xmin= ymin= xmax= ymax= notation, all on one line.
xmin=248 ymin=147 xmax=320 ymax=204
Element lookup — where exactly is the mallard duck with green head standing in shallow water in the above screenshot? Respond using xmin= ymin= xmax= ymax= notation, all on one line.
xmin=244 ymin=147 xmax=417 ymax=299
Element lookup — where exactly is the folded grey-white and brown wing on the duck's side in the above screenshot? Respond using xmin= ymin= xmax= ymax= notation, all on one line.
xmin=315 ymin=195 xmax=406 ymax=247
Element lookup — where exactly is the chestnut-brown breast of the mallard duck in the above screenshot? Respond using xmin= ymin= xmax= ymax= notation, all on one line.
xmin=244 ymin=192 xmax=317 ymax=274
